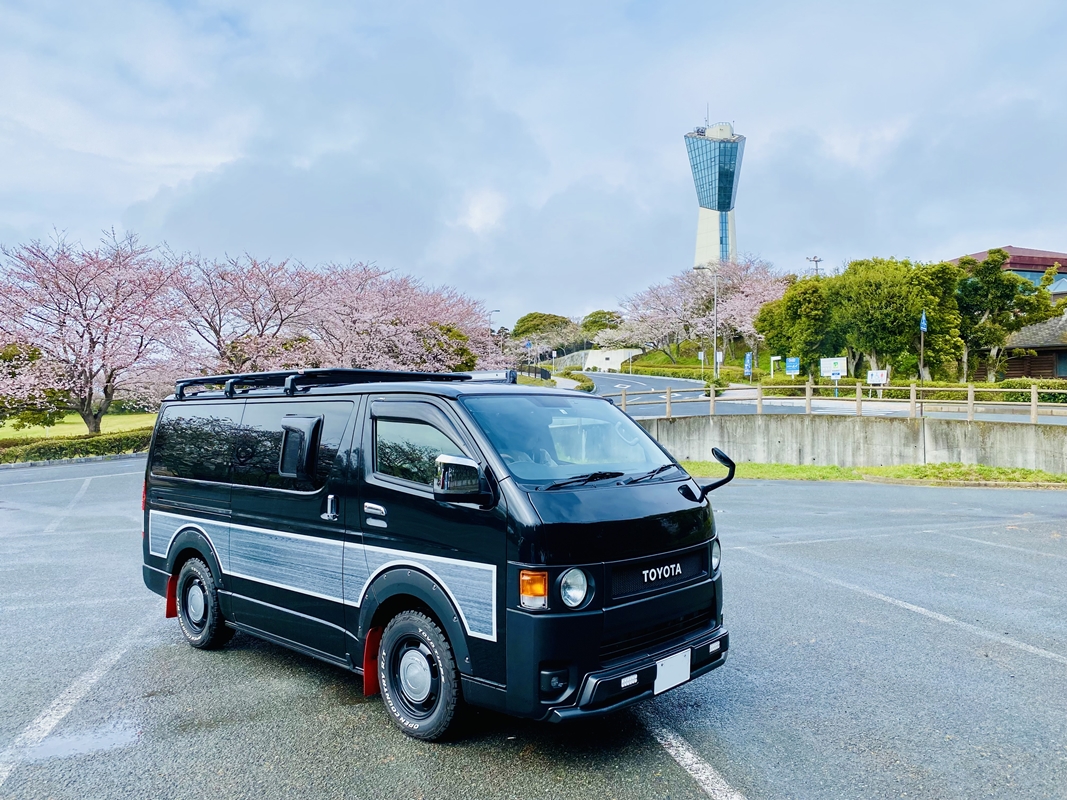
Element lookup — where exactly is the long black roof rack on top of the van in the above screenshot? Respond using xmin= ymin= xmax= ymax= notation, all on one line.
xmin=166 ymin=369 xmax=584 ymax=401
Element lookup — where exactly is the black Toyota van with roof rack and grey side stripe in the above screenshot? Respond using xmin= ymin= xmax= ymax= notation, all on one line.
xmin=143 ymin=370 xmax=733 ymax=739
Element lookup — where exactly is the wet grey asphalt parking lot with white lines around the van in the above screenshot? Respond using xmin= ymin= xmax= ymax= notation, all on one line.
xmin=0 ymin=460 xmax=1067 ymax=800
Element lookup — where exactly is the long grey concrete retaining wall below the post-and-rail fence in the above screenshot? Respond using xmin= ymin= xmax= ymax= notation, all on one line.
xmin=638 ymin=414 xmax=1067 ymax=473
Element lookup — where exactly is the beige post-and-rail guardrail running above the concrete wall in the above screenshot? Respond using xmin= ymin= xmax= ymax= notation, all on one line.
xmin=601 ymin=383 xmax=1067 ymax=425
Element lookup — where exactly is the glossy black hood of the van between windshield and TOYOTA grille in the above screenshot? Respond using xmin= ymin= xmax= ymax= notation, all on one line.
xmin=527 ymin=480 xmax=715 ymax=564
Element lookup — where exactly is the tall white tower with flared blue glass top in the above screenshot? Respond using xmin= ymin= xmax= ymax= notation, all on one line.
xmin=685 ymin=123 xmax=745 ymax=266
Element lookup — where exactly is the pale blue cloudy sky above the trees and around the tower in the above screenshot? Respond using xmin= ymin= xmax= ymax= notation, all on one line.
xmin=0 ymin=0 xmax=1067 ymax=324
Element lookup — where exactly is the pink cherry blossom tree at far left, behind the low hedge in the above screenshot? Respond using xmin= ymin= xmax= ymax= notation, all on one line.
xmin=0 ymin=231 xmax=180 ymax=433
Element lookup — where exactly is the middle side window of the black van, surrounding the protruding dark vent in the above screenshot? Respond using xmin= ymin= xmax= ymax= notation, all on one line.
xmin=234 ymin=401 xmax=352 ymax=492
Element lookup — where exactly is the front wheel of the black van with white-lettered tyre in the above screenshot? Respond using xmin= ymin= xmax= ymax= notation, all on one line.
xmin=378 ymin=611 xmax=460 ymax=740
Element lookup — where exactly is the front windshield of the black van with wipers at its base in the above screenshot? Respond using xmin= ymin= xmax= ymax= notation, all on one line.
xmin=462 ymin=395 xmax=676 ymax=489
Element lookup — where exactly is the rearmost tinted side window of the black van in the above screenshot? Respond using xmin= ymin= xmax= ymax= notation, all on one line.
xmin=152 ymin=402 xmax=241 ymax=483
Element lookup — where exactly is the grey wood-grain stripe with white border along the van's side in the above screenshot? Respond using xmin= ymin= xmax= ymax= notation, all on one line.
xmin=148 ymin=510 xmax=496 ymax=642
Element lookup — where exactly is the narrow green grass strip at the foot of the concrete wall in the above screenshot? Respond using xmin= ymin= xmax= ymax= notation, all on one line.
xmin=682 ymin=461 xmax=1067 ymax=487
